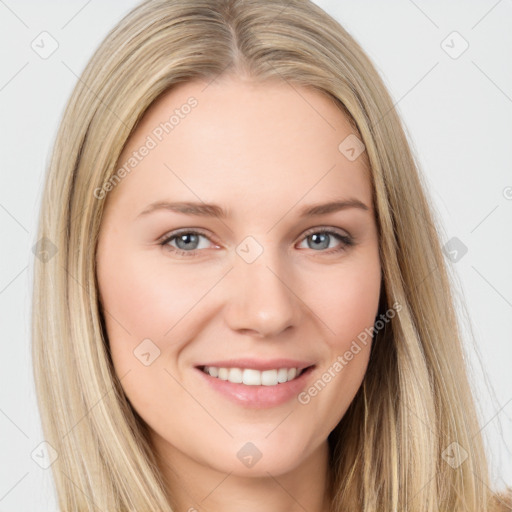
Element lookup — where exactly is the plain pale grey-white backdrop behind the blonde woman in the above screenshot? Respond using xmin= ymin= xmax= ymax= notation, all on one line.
xmin=0 ymin=0 xmax=512 ymax=512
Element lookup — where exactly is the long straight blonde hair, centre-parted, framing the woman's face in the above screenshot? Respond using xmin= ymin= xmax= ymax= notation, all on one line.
xmin=32 ymin=0 xmax=508 ymax=512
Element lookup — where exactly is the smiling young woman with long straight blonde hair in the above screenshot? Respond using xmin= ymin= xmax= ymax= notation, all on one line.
xmin=33 ymin=0 xmax=507 ymax=512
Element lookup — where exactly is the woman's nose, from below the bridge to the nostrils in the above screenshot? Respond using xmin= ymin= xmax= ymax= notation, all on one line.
xmin=225 ymin=250 xmax=300 ymax=337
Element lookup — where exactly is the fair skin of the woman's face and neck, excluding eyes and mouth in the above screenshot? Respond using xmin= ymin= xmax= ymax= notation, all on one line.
xmin=97 ymin=76 xmax=381 ymax=512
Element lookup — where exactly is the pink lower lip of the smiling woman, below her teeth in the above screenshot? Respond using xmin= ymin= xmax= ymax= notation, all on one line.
xmin=195 ymin=366 xmax=315 ymax=409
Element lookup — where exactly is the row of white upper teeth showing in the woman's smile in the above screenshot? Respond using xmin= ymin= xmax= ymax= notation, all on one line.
xmin=203 ymin=366 xmax=302 ymax=386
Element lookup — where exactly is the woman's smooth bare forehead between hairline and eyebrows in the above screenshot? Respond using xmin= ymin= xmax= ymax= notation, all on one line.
xmin=109 ymin=77 xmax=371 ymax=217
